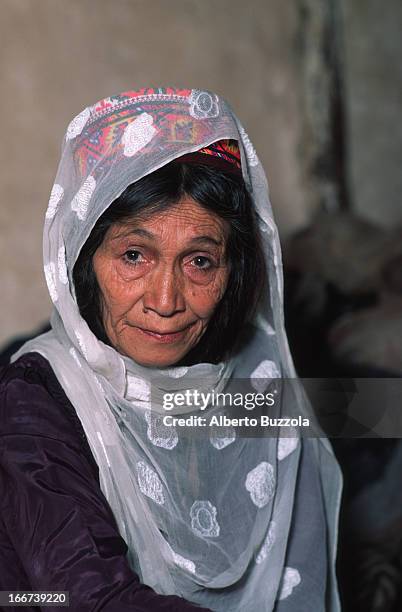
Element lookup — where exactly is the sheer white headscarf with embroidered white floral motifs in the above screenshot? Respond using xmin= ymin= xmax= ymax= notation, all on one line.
xmin=15 ymin=89 xmax=340 ymax=612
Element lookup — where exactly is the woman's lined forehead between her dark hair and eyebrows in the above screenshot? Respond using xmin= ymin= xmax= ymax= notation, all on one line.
xmin=107 ymin=197 xmax=228 ymax=240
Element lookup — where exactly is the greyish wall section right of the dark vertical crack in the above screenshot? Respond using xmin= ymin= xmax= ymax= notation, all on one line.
xmin=342 ymin=0 xmax=402 ymax=227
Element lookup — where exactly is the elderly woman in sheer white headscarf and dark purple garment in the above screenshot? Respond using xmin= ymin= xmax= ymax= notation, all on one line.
xmin=0 ymin=89 xmax=340 ymax=612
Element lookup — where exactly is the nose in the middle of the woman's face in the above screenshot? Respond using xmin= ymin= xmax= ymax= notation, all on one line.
xmin=143 ymin=266 xmax=185 ymax=317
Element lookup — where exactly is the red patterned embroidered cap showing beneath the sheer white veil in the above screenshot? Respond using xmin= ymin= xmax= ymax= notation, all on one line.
xmin=69 ymin=87 xmax=229 ymax=178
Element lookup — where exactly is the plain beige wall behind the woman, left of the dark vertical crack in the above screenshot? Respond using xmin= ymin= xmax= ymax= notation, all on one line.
xmin=0 ymin=0 xmax=307 ymax=342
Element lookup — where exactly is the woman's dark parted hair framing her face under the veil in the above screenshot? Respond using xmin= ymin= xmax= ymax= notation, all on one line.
xmin=73 ymin=160 xmax=265 ymax=364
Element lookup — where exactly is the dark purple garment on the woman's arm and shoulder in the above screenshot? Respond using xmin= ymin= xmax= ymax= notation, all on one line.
xmin=0 ymin=353 xmax=212 ymax=612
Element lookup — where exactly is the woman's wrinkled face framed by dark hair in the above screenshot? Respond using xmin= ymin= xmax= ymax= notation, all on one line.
xmin=93 ymin=197 xmax=229 ymax=367
